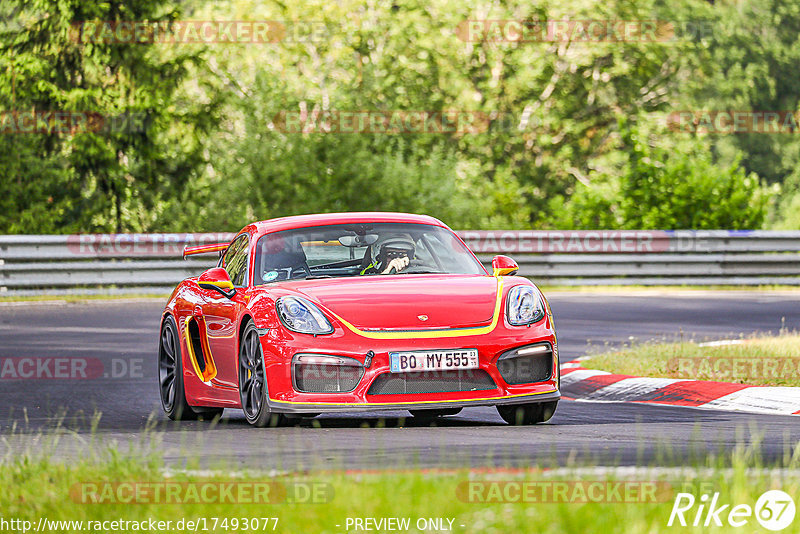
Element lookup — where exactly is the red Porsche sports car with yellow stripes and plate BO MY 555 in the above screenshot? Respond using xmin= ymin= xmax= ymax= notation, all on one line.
xmin=158 ymin=213 xmax=560 ymax=426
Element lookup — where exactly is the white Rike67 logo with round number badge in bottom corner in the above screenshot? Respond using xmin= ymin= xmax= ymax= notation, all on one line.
xmin=667 ymin=490 xmax=795 ymax=531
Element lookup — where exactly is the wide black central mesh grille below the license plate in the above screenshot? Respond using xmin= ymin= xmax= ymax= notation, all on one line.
xmin=367 ymin=369 xmax=497 ymax=395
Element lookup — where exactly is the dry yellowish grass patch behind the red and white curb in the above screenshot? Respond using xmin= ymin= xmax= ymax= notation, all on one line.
xmin=582 ymin=333 xmax=800 ymax=386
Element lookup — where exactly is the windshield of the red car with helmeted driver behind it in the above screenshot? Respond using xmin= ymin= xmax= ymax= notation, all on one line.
xmin=254 ymin=223 xmax=486 ymax=285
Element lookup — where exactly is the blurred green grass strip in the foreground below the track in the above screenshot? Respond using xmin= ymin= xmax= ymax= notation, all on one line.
xmin=0 ymin=445 xmax=800 ymax=534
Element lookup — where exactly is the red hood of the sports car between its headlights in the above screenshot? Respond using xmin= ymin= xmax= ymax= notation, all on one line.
xmin=294 ymin=275 xmax=497 ymax=330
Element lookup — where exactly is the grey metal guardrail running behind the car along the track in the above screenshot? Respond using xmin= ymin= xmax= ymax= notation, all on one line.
xmin=0 ymin=230 xmax=800 ymax=295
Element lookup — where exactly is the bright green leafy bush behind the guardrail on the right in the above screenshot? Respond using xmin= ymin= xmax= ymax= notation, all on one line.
xmin=554 ymin=122 xmax=770 ymax=230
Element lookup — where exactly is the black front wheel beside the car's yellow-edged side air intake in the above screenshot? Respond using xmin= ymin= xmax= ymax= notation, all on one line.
xmin=239 ymin=322 xmax=284 ymax=428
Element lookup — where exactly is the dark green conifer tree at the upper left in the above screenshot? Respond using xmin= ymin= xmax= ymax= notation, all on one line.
xmin=0 ymin=0 xmax=222 ymax=232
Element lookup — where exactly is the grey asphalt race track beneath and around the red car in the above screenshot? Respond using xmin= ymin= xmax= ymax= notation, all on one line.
xmin=0 ymin=291 xmax=800 ymax=470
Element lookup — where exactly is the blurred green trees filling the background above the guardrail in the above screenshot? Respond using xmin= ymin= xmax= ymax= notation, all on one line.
xmin=0 ymin=0 xmax=800 ymax=233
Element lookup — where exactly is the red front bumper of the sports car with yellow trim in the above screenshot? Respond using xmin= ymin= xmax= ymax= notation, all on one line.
xmin=261 ymin=317 xmax=561 ymax=414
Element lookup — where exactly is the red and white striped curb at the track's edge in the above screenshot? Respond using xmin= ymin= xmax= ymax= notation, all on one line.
xmin=561 ymin=360 xmax=800 ymax=415
